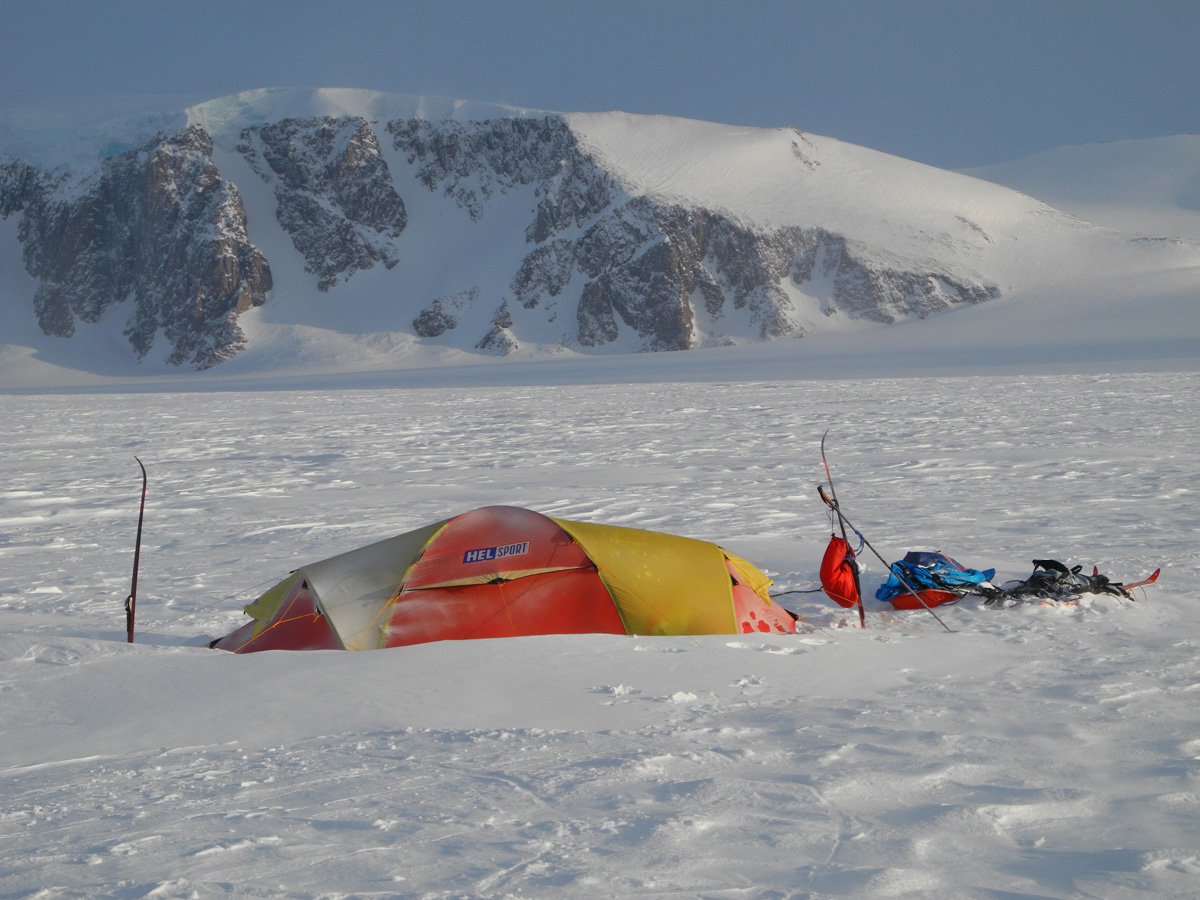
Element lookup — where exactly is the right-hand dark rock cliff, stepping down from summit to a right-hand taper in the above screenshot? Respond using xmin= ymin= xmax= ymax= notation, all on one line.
xmin=389 ymin=116 xmax=1000 ymax=350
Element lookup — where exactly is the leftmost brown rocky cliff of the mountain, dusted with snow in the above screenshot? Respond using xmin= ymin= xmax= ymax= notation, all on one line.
xmin=0 ymin=127 xmax=271 ymax=368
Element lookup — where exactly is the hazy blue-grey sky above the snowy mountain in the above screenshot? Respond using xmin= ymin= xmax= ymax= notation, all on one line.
xmin=0 ymin=0 xmax=1200 ymax=168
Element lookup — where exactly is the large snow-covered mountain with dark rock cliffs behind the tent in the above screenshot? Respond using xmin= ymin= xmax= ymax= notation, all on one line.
xmin=0 ymin=90 xmax=1200 ymax=374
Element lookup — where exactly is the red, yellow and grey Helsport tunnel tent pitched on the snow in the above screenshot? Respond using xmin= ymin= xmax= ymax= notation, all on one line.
xmin=211 ymin=506 xmax=796 ymax=653
